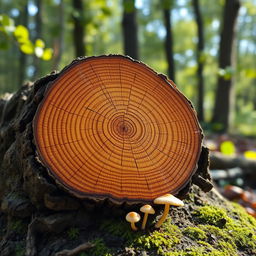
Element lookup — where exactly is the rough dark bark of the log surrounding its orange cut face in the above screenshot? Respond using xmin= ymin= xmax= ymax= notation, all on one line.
xmin=0 ymin=58 xmax=218 ymax=256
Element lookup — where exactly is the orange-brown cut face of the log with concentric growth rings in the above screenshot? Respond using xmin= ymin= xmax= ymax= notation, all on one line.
xmin=34 ymin=55 xmax=201 ymax=202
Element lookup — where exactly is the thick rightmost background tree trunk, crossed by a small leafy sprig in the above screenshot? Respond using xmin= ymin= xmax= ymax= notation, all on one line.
xmin=212 ymin=0 xmax=240 ymax=132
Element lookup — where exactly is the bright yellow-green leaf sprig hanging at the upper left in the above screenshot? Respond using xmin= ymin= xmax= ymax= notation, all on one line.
xmin=0 ymin=14 xmax=52 ymax=61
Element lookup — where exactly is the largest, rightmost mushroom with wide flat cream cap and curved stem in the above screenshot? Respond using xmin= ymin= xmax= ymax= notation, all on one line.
xmin=154 ymin=194 xmax=184 ymax=228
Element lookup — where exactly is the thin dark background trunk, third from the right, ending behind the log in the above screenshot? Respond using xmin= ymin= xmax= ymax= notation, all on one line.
xmin=163 ymin=1 xmax=175 ymax=82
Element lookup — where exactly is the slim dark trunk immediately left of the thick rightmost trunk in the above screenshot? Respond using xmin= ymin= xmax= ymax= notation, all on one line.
xmin=193 ymin=0 xmax=204 ymax=121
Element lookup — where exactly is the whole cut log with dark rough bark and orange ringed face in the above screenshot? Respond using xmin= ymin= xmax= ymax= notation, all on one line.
xmin=0 ymin=55 xmax=212 ymax=255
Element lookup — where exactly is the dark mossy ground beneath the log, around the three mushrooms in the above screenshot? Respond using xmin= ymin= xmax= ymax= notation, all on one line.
xmin=0 ymin=187 xmax=256 ymax=256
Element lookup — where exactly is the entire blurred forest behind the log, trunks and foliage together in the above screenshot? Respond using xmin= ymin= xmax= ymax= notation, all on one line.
xmin=0 ymin=0 xmax=256 ymax=136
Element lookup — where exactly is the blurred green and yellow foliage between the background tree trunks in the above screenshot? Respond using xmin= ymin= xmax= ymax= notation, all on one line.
xmin=0 ymin=0 xmax=256 ymax=135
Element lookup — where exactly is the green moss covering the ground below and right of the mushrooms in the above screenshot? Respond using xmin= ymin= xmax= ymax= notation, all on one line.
xmin=95 ymin=201 xmax=256 ymax=256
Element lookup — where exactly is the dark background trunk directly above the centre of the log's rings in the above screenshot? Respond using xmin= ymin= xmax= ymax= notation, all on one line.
xmin=122 ymin=0 xmax=139 ymax=59
